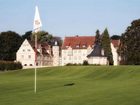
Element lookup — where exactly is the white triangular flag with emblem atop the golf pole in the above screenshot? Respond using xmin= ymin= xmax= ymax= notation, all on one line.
xmin=33 ymin=6 xmax=42 ymax=32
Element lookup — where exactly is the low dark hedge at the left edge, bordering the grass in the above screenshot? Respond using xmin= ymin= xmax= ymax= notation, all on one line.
xmin=0 ymin=61 xmax=22 ymax=71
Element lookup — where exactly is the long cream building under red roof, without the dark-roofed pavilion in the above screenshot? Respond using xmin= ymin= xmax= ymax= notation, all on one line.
xmin=61 ymin=36 xmax=95 ymax=66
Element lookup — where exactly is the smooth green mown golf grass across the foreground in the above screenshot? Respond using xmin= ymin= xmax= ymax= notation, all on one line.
xmin=0 ymin=66 xmax=140 ymax=105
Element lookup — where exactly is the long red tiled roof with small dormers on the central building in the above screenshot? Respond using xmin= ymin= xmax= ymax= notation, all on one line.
xmin=62 ymin=36 xmax=95 ymax=49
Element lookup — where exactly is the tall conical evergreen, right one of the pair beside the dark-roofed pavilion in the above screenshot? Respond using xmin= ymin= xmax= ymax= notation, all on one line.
xmin=101 ymin=28 xmax=113 ymax=65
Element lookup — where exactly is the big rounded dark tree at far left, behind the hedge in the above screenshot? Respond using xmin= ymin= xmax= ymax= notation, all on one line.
xmin=0 ymin=31 xmax=23 ymax=61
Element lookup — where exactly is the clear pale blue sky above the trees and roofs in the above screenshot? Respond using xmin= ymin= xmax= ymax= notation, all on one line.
xmin=0 ymin=0 xmax=140 ymax=37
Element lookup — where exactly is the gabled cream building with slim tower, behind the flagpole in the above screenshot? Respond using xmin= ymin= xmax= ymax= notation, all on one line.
xmin=16 ymin=39 xmax=59 ymax=68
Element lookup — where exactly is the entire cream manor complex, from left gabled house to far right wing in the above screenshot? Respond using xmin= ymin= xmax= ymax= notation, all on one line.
xmin=16 ymin=36 xmax=120 ymax=68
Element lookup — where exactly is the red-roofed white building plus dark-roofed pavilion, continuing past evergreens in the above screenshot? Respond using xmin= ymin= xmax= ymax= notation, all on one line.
xmin=61 ymin=36 xmax=119 ymax=65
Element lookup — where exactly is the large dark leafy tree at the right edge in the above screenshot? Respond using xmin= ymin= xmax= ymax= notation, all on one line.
xmin=118 ymin=19 xmax=140 ymax=65
